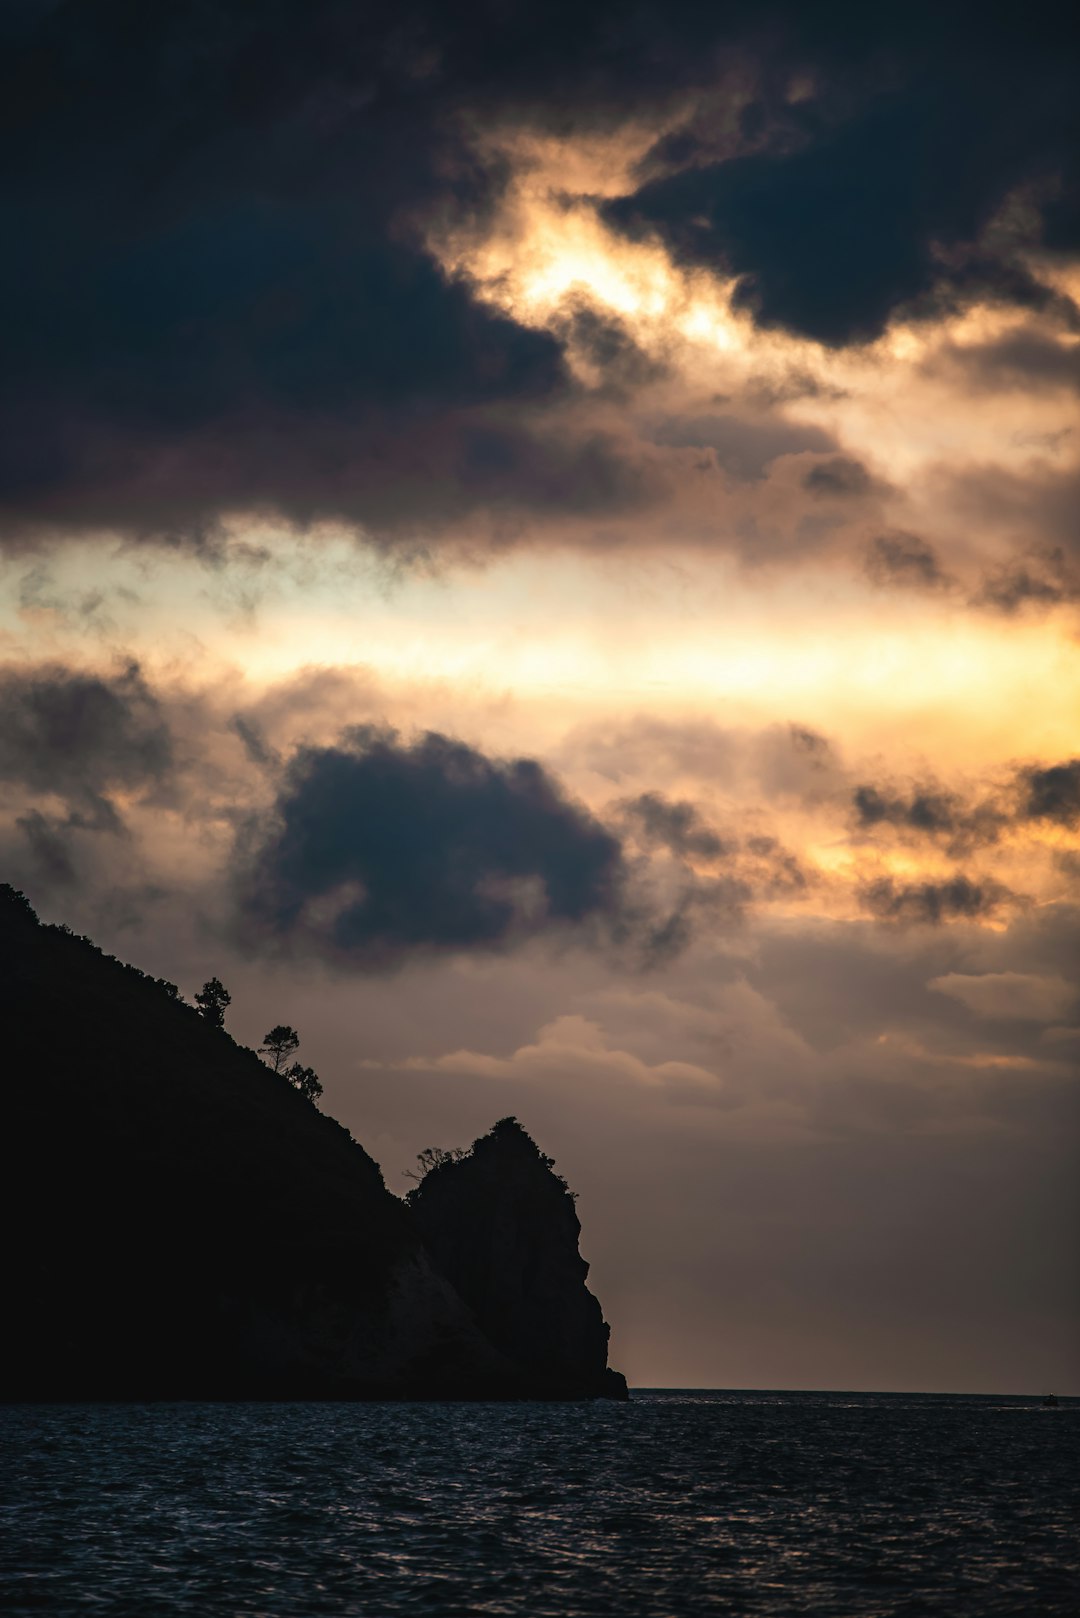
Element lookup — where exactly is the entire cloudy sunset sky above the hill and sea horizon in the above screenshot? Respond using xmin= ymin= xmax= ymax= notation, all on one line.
xmin=0 ymin=0 xmax=1080 ymax=1393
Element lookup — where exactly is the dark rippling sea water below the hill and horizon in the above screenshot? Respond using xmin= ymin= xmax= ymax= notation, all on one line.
xmin=0 ymin=1390 xmax=1080 ymax=1618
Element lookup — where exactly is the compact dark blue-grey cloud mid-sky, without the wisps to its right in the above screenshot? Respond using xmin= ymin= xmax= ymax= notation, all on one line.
xmin=241 ymin=728 xmax=623 ymax=968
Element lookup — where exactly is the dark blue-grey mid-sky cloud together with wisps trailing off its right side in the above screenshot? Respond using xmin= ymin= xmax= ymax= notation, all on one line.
xmin=236 ymin=726 xmax=822 ymax=969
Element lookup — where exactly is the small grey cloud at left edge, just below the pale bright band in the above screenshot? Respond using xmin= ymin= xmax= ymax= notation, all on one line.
xmin=0 ymin=663 xmax=173 ymax=815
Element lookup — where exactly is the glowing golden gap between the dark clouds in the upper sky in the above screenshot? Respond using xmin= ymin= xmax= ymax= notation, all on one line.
xmin=432 ymin=129 xmax=1080 ymax=504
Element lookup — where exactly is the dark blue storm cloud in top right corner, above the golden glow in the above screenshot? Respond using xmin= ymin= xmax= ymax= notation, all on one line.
xmin=609 ymin=5 xmax=1080 ymax=345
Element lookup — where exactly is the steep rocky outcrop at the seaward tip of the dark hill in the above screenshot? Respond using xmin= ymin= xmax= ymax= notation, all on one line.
xmin=408 ymin=1118 xmax=625 ymax=1398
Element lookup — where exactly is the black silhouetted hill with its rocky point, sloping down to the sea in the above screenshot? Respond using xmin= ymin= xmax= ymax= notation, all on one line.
xmin=0 ymin=887 xmax=625 ymax=1400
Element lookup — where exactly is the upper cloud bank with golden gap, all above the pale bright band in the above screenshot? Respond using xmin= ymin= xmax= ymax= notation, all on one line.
xmin=0 ymin=0 xmax=1078 ymax=613
